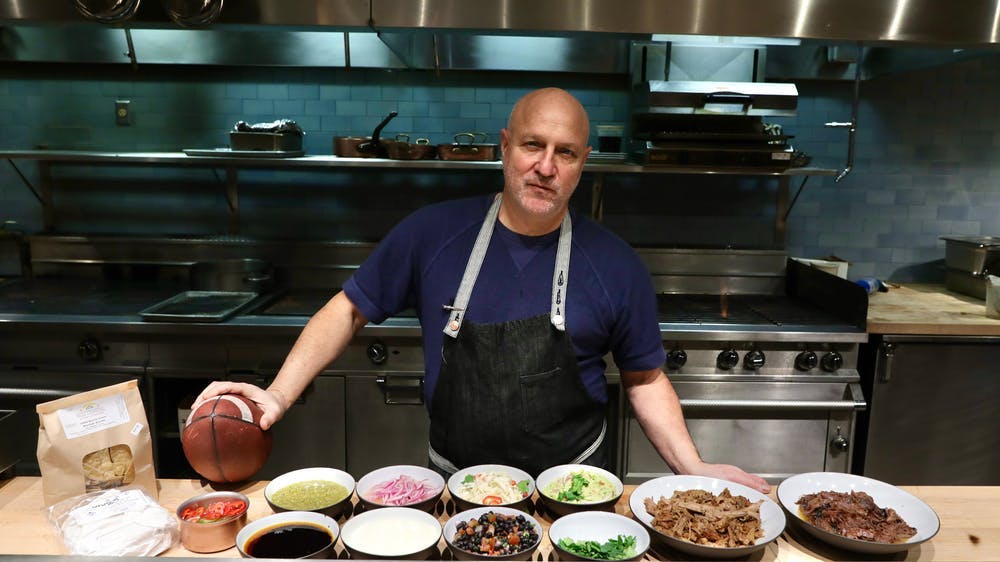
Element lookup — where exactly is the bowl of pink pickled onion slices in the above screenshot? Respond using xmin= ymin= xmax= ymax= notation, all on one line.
xmin=357 ymin=464 xmax=445 ymax=512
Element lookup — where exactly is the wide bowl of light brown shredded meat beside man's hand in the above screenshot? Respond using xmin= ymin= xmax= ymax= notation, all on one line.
xmin=629 ymin=475 xmax=785 ymax=558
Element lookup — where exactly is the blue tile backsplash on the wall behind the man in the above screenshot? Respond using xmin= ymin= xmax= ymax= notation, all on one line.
xmin=0 ymin=56 xmax=1000 ymax=282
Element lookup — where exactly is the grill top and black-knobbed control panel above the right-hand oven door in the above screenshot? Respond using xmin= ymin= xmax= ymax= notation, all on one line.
xmin=657 ymin=260 xmax=867 ymax=380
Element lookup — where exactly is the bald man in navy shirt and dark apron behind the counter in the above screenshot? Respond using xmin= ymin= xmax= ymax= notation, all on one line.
xmin=198 ymin=88 xmax=769 ymax=492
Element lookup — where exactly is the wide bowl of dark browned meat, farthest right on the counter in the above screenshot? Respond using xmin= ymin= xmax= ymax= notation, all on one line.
xmin=777 ymin=472 xmax=941 ymax=554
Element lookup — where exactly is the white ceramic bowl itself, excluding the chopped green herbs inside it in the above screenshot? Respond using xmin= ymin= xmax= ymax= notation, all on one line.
xmin=549 ymin=511 xmax=650 ymax=560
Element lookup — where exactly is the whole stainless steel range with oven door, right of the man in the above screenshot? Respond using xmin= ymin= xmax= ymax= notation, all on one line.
xmin=622 ymin=250 xmax=867 ymax=483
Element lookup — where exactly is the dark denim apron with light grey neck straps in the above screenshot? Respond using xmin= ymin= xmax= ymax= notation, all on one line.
xmin=429 ymin=195 xmax=609 ymax=476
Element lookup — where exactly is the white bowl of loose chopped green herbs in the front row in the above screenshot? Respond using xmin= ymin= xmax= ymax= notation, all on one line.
xmin=549 ymin=511 xmax=650 ymax=560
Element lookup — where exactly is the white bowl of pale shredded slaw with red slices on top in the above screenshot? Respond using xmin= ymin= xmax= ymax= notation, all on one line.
xmin=448 ymin=464 xmax=535 ymax=511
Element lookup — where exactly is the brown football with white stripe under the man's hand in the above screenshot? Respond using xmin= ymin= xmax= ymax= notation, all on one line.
xmin=181 ymin=394 xmax=271 ymax=482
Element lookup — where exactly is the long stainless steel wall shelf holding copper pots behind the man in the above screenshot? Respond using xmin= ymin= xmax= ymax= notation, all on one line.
xmin=0 ymin=150 xmax=839 ymax=176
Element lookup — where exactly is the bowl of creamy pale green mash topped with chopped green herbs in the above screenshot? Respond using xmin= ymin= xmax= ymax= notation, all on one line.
xmin=536 ymin=464 xmax=625 ymax=518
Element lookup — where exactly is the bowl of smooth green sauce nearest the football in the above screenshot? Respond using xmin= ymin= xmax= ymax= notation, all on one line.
xmin=264 ymin=467 xmax=356 ymax=519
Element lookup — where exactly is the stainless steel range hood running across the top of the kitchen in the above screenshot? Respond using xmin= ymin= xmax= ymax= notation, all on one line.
xmin=0 ymin=0 xmax=1000 ymax=73
